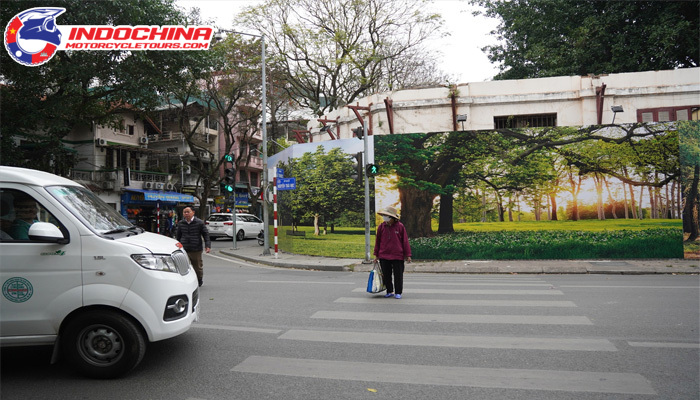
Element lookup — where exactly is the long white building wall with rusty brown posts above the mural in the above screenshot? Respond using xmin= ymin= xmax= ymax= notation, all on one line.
xmin=305 ymin=68 xmax=700 ymax=142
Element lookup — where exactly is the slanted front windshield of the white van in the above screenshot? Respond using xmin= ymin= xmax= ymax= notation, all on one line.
xmin=46 ymin=186 xmax=135 ymax=234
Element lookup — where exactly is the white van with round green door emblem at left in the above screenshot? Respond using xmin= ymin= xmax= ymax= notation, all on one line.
xmin=0 ymin=166 xmax=199 ymax=378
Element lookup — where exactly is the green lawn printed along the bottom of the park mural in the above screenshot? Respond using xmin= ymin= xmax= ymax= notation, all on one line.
xmin=279 ymin=219 xmax=683 ymax=260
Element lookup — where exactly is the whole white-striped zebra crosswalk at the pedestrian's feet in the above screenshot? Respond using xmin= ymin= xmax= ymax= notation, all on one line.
xmin=232 ymin=276 xmax=656 ymax=398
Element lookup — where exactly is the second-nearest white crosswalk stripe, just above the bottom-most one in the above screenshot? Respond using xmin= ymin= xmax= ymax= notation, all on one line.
xmin=279 ymin=329 xmax=617 ymax=351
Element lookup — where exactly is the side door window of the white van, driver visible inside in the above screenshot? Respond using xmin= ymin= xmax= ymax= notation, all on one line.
xmin=0 ymin=189 xmax=68 ymax=242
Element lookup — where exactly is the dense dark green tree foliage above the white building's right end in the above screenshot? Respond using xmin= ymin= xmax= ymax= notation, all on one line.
xmin=472 ymin=0 xmax=700 ymax=79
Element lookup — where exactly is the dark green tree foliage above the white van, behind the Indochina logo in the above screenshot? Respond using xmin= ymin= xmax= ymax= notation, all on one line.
xmin=0 ymin=0 xmax=209 ymax=173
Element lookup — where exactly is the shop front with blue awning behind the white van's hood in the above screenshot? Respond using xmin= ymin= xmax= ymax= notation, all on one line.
xmin=121 ymin=189 xmax=195 ymax=236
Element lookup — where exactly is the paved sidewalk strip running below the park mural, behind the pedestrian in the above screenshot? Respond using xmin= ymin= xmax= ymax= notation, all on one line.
xmin=218 ymin=246 xmax=700 ymax=275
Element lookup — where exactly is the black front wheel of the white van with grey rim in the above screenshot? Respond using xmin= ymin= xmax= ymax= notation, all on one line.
xmin=61 ymin=310 xmax=146 ymax=379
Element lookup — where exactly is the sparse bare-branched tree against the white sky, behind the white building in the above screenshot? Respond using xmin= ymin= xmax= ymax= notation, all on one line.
xmin=242 ymin=0 xmax=444 ymax=115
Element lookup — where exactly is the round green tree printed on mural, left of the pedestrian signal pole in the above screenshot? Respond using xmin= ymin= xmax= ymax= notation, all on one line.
xmin=280 ymin=146 xmax=364 ymax=235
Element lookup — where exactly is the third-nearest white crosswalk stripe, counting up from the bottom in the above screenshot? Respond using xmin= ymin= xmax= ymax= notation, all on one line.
xmin=311 ymin=310 xmax=593 ymax=325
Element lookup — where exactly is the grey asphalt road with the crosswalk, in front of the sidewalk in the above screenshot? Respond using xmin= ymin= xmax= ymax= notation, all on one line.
xmin=0 ymin=240 xmax=700 ymax=400
